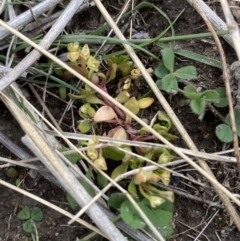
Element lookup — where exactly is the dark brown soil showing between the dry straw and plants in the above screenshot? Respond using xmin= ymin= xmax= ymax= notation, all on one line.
xmin=0 ymin=0 xmax=240 ymax=241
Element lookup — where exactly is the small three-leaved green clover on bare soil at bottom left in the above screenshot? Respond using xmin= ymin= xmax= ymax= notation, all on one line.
xmin=18 ymin=206 xmax=43 ymax=241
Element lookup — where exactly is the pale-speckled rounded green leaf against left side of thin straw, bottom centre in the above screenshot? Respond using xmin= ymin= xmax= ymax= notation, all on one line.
xmin=121 ymin=200 xmax=146 ymax=229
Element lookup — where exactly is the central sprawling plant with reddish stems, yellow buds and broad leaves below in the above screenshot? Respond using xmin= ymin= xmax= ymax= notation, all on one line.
xmin=60 ymin=43 xmax=177 ymax=237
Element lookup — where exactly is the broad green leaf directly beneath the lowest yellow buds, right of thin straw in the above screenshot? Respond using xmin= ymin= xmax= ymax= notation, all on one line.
xmin=140 ymin=199 xmax=173 ymax=239
